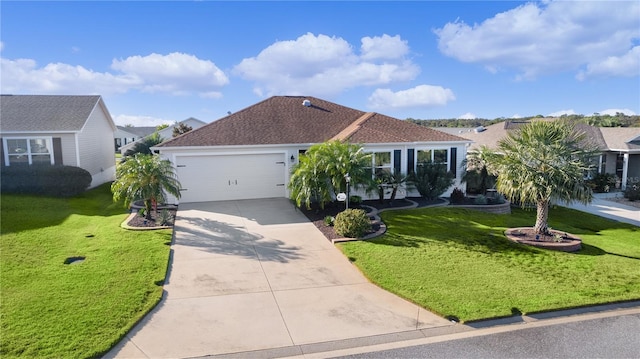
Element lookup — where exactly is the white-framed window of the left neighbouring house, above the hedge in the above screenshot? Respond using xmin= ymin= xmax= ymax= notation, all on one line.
xmin=2 ymin=138 xmax=54 ymax=166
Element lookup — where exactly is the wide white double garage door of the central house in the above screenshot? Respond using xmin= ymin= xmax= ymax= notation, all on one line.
xmin=176 ymin=154 xmax=286 ymax=203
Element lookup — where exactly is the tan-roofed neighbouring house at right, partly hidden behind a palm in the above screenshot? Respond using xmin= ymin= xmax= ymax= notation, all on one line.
xmin=436 ymin=118 xmax=640 ymax=189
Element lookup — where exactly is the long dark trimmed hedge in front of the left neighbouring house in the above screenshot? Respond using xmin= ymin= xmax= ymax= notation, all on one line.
xmin=0 ymin=165 xmax=91 ymax=197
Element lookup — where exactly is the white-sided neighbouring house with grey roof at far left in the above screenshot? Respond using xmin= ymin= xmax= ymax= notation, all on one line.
xmin=0 ymin=95 xmax=116 ymax=187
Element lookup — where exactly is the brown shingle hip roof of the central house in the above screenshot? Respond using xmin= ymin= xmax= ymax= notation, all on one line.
xmin=158 ymin=96 xmax=465 ymax=147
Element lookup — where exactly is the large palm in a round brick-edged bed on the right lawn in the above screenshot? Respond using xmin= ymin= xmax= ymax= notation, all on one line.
xmin=496 ymin=121 xmax=597 ymax=234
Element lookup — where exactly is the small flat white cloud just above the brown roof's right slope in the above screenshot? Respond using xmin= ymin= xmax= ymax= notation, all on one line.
xmin=369 ymin=85 xmax=456 ymax=108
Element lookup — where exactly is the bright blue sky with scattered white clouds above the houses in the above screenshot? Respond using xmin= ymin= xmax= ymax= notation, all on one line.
xmin=0 ymin=1 xmax=640 ymax=126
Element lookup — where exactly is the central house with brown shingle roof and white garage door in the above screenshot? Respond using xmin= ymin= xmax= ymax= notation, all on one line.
xmin=154 ymin=96 xmax=470 ymax=203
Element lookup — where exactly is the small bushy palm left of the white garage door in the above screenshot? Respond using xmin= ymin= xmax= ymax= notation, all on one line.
xmin=111 ymin=153 xmax=180 ymax=220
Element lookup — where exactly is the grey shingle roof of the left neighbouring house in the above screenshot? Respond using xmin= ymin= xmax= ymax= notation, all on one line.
xmin=0 ymin=95 xmax=100 ymax=132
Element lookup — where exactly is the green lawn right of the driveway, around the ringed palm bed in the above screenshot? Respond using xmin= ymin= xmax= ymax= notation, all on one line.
xmin=339 ymin=207 xmax=640 ymax=321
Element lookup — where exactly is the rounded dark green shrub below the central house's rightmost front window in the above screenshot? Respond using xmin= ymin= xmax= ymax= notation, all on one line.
xmin=410 ymin=162 xmax=455 ymax=200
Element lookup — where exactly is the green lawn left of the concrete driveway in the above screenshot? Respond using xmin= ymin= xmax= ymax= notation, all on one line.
xmin=0 ymin=185 xmax=171 ymax=358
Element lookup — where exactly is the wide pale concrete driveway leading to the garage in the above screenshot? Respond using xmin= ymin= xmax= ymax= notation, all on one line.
xmin=106 ymin=199 xmax=452 ymax=358
